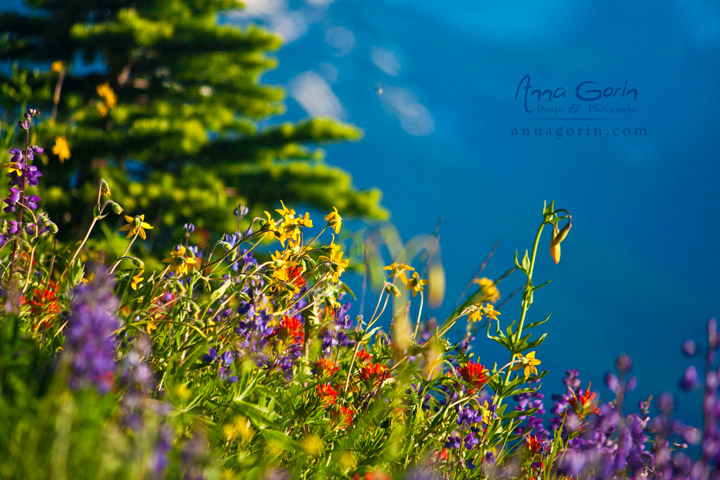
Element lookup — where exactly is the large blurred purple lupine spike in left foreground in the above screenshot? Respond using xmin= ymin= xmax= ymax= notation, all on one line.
xmin=63 ymin=266 xmax=120 ymax=393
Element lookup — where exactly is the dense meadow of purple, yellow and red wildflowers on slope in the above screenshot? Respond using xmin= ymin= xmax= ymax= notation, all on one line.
xmin=0 ymin=109 xmax=720 ymax=480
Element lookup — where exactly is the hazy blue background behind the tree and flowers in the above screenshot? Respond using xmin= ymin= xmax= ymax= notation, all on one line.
xmin=226 ymin=0 xmax=720 ymax=420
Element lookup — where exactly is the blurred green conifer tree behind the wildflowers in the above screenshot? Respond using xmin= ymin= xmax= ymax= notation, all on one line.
xmin=0 ymin=0 xmax=386 ymax=253
